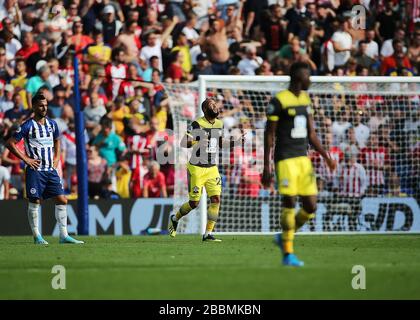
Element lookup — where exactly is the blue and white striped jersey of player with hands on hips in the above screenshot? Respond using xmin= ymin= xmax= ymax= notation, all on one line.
xmin=14 ymin=118 xmax=60 ymax=171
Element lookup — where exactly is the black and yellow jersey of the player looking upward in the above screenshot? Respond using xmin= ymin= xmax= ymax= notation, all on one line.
xmin=187 ymin=117 xmax=223 ymax=167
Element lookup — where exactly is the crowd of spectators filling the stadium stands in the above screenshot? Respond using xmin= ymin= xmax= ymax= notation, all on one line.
xmin=0 ymin=0 xmax=420 ymax=199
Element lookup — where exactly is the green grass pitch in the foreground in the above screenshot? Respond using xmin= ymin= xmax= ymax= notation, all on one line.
xmin=0 ymin=235 xmax=420 ymax=299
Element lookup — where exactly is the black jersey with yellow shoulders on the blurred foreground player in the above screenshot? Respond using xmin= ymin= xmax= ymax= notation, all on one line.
xmin=267 ymin=90 xmax=312 ymax=161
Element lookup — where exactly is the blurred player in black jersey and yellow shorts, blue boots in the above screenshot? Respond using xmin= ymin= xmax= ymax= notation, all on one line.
xmin=262 ymin=62 xmax=336 ymax=267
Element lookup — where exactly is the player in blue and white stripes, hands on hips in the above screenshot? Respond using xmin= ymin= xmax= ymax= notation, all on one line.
xmin=7 ymin=93 xmax=83 ymax=245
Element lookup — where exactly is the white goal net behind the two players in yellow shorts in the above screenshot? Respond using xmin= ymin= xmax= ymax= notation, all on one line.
xmin=167 ymin=76 xmax=420 ymax=233
